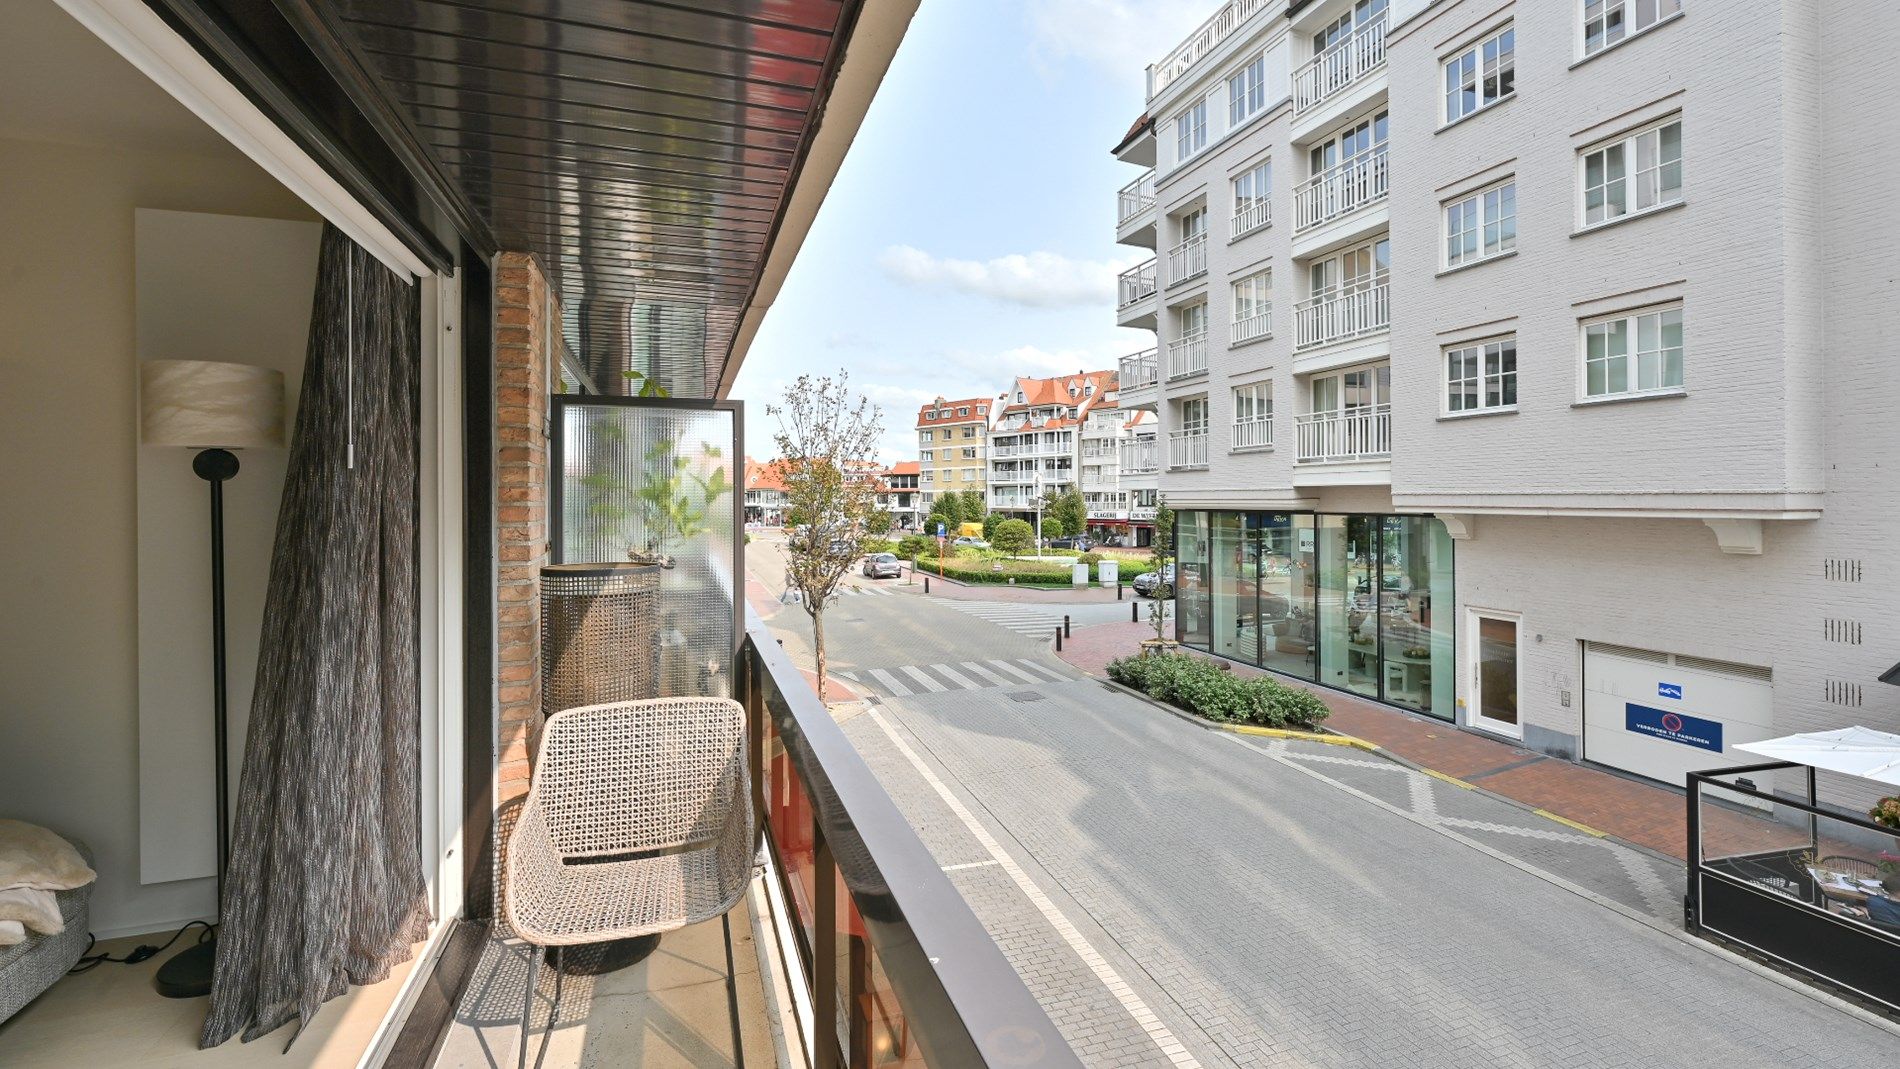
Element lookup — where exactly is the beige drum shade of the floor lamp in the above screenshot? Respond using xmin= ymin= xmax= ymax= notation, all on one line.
xmin=139 ymin=361 xmax=283 ymax=450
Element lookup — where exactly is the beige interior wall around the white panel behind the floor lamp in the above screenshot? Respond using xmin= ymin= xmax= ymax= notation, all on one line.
xmin=0 ymin=141 xmax=314 ymax=934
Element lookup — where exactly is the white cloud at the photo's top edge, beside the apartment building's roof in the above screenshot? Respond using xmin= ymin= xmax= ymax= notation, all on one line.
xmin=1024 ymin=0 xmax=1216 ymax=80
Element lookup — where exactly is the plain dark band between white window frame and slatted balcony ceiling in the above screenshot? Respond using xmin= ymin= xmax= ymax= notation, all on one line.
xmin=144 ymin=0 xmax=475 ymax=272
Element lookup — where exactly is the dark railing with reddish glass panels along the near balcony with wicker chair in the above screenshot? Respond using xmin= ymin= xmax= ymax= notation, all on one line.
xmin=735 ymin=611 xmax=1081 ymax=1069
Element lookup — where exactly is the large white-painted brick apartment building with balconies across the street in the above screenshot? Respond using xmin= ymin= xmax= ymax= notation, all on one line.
xmin=1115 ymin=0 xmax=1900 ymax=807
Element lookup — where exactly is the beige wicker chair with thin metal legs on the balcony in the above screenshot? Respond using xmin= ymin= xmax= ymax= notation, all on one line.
xmin=504 ymin=699 xmax=754 ymax=1065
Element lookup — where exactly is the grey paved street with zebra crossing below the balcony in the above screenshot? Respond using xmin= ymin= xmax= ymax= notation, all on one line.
xmin=749 ymin=539 xmax=1900 ymax=1067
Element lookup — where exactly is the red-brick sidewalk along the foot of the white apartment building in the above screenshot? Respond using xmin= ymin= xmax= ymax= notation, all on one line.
xmin=1058 ymin=621 xmax=1687 ymax=858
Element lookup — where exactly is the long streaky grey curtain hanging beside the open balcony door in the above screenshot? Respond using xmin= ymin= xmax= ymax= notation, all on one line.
xmin=200 ymin=226 xmax=429 ymax=1046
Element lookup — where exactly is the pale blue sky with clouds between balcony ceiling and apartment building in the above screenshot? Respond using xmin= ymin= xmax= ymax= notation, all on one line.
xmin=733 ymin=0 xmax=1218 ymax=463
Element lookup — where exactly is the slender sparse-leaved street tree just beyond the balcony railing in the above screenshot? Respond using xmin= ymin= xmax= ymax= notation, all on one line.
xmin=766 ymin=370 xmax=884 ymax=701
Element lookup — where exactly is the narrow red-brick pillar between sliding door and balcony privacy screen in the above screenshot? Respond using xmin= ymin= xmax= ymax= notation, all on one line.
xmin=494 ymin=253 xmax=551 ymax=807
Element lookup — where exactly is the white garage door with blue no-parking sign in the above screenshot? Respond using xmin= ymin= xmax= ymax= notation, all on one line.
xmin=1583 ymin=642 xmax=1775 ymax=786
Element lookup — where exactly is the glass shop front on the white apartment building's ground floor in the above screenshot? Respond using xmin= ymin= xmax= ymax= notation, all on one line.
xmin=1174 ymin=511 xmax=1455 ymax=720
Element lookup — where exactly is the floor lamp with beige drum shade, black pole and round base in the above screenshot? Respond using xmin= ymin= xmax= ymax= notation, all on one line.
xmin=139 ymin=361 xmax=283 ymax=999
